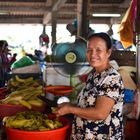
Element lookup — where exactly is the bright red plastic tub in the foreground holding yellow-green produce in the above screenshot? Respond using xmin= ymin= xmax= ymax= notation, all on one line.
xmin=5 ymin=117 xmax=70 ymax=140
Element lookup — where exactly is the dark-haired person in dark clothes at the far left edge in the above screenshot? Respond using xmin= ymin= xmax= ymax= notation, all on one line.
xmin=0 ymin=40 xmax=10 ymax=87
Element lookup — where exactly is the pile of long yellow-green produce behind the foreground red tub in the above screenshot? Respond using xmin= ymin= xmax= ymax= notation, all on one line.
xmin=0 ymin=75 xmax=44 ymax=109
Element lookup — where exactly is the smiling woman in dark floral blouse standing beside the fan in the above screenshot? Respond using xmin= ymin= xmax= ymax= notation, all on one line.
xmin=56 ymin=33 xmax=124 ymax=140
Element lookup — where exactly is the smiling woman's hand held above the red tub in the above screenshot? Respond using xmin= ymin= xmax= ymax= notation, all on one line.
xmin=54 ymin=103 xmax=74 ymax=117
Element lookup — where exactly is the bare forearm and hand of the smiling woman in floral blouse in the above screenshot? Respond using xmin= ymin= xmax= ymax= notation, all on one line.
xmin=56 ymin=96 xmax=115 ymax=120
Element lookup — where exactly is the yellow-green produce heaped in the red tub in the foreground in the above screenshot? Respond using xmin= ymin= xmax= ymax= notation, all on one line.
xmin=3 ymin=111 xmax=63 ymax=131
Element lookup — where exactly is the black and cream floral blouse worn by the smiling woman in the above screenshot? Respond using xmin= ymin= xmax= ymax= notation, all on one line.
xmin=72 ymin=67 xmax=124 ymax=140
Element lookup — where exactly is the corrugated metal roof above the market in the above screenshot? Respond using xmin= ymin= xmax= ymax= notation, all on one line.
xmin=0 ymin=0 xmax=130 ymax=24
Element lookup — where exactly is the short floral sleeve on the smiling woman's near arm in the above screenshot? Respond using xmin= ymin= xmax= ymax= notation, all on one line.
xmin=97 ymin=74 xmax=123 ymax=101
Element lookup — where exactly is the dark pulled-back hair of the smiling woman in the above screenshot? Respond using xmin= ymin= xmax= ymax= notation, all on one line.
xmin=88 ymin=32 xmax=112 ymax=49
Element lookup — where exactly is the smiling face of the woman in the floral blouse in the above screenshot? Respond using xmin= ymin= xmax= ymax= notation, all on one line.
xmin=86 ymin=37 xmax=111 ymax=68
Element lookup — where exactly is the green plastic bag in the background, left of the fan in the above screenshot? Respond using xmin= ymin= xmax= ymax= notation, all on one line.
xmin=11 ymin=56 xmax=35 ymax=69
